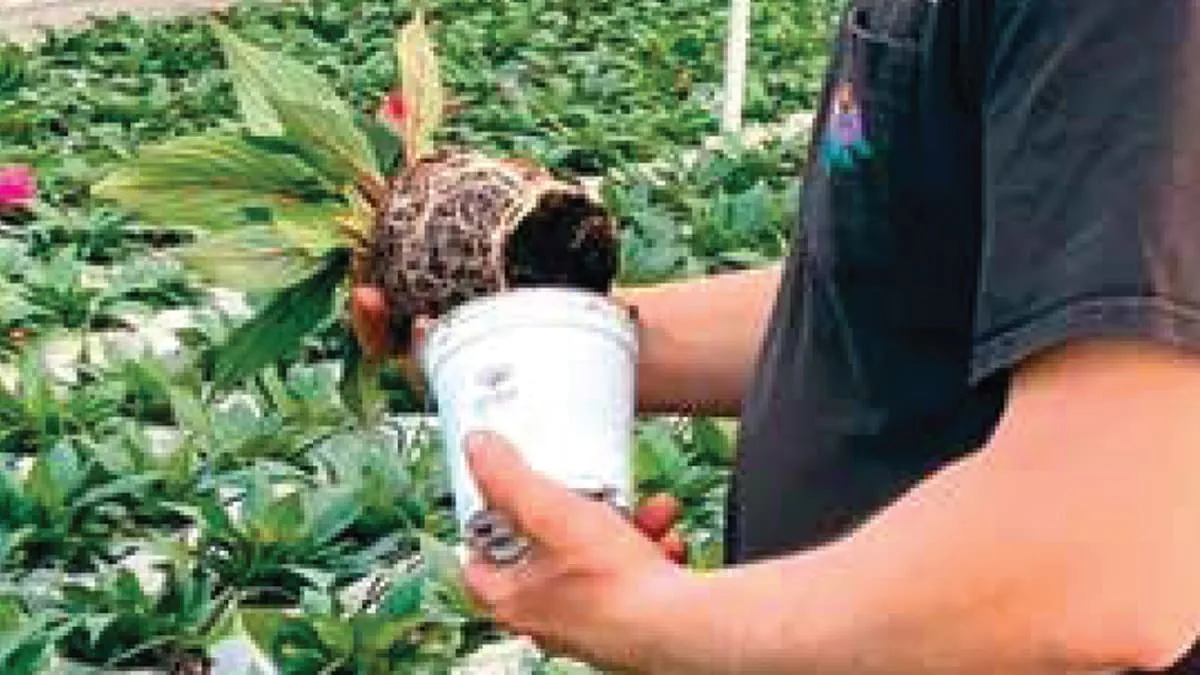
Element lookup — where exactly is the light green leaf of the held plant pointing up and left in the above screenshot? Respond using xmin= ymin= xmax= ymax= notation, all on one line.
xmin=214 ymin=23 xmax=380 ymax=181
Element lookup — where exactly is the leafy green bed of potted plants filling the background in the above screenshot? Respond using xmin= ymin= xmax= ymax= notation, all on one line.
xmin=0 ymin=0 xmax=836 ymax=674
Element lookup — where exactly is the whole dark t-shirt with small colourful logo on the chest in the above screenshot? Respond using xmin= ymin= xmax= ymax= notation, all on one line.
xmin=727 ymin=0 xmax=1200 ymax=671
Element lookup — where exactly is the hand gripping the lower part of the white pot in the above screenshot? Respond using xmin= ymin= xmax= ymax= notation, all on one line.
xmin=464 ymin=436 xmax=697 ymax=669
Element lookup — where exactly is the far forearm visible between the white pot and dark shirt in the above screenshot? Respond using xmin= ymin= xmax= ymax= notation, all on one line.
xmin=614 ymin=264 xmax=781 ymax=416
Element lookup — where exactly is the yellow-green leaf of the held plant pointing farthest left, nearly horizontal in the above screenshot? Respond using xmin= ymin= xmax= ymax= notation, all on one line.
xmin=92 ymin=133 xmax=344 ymax=235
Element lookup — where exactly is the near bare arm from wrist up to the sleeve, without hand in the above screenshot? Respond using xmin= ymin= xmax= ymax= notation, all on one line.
xmin=631 ymin=344 xmax=1200 ymax=675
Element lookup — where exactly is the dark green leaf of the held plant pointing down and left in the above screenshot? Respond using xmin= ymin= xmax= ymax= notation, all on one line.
xmin=212 ymin=249 xmax=350 ymax=392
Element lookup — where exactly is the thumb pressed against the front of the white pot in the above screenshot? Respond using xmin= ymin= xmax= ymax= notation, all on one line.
xmin=467 ymin=434 xmax=595 ymax=546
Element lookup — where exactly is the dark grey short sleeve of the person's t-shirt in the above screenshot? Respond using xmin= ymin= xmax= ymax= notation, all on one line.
xmin=972 ymin=0 xmax=1200 ymax=381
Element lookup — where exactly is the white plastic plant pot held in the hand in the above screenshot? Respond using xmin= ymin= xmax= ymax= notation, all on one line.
xmin=421 ymin=288 xmax=637 ymax=554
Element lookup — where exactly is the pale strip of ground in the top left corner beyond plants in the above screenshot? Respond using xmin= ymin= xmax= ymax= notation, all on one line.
xmin=0 ymin=0 xmax=282 ymax=43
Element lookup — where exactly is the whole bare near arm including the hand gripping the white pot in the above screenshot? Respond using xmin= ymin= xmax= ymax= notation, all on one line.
xmin=466 ymin=341 xmax=1200 ymax=675
